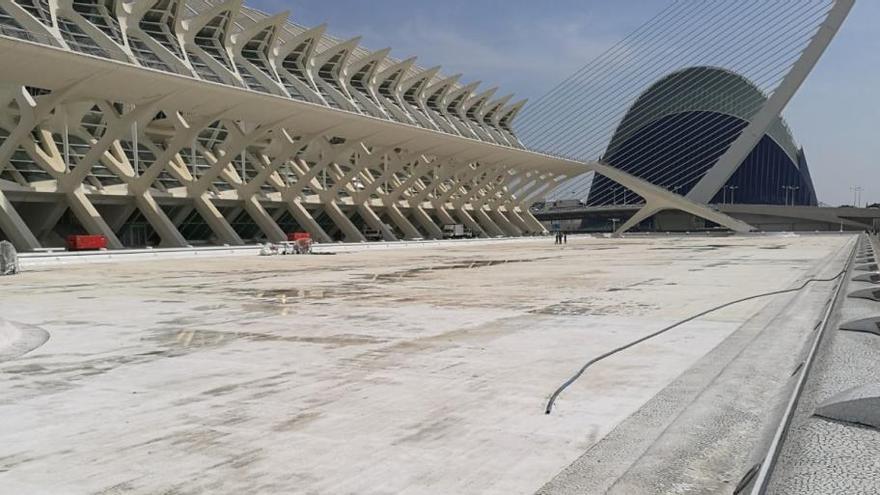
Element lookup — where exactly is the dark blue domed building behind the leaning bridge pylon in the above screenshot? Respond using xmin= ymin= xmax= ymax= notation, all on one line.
xmin=587 ymin=67 xmax=818 ymax=206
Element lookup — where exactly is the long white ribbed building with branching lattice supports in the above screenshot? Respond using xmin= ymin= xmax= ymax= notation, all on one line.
xmin=0 ymin=0 xmax=764 ymax=250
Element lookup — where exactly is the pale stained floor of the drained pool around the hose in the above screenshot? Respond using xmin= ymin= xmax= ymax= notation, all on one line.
xmin=0 ymin=235 xmax=850 ymax=494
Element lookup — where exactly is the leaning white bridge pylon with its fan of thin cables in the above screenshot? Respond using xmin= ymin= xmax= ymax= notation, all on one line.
xmin=516 ymin=0 xmax=855 ymax=233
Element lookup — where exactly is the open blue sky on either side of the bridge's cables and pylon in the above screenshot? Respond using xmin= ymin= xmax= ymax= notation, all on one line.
xmin=253 ymin=0 xmax=880 ymax=204
